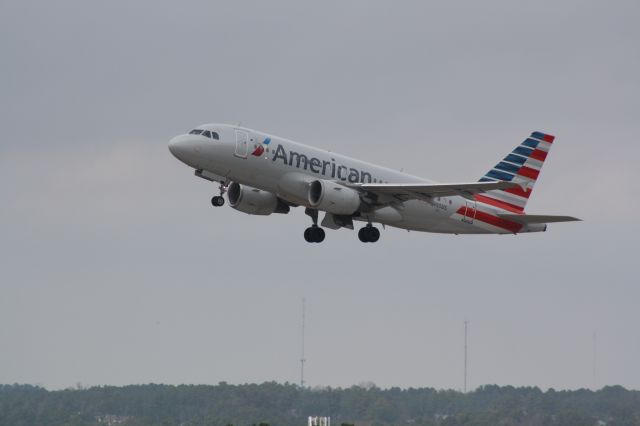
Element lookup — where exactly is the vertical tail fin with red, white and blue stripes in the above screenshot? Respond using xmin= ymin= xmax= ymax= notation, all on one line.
xmin=476 ymin=132 xmax=555 ymax=213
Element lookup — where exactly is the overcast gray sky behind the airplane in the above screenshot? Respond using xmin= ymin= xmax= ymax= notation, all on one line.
xmin=0 ymin=0 xmax=640 ymax=389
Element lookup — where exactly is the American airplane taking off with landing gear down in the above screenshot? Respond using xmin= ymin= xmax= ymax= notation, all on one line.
xmin=169 ymin=124 xmax=580 ymax=243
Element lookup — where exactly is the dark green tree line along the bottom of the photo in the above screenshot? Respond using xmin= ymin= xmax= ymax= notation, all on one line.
xmin=0 ymin=382 xmax=640 ymax=426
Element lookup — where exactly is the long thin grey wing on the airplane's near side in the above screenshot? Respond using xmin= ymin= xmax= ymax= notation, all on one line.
xmin=346 ymin=181 xmax=519 ymax=201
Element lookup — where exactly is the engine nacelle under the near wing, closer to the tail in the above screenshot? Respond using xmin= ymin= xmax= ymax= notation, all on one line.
xmin=308 ymin=180 xmax=361 ymax=215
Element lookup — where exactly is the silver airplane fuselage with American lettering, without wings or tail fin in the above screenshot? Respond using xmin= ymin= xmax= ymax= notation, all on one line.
xmin=169 ymin=124 xmax=546 ymax=234
